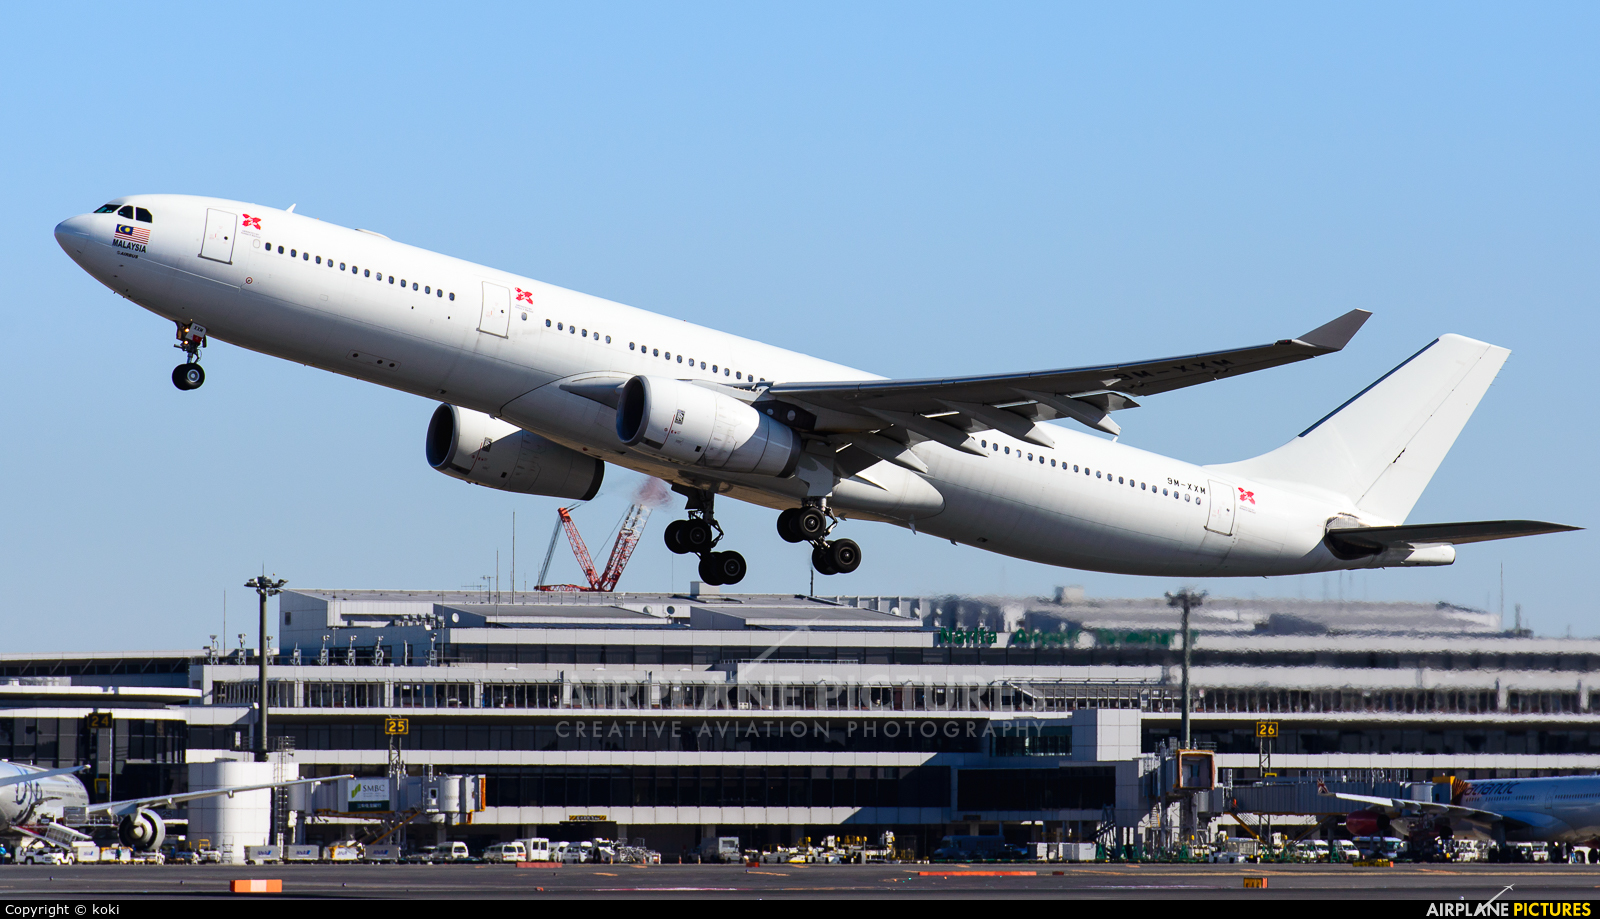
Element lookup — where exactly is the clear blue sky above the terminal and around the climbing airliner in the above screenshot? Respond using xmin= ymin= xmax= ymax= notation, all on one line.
xmin=0 ymin=3 xmax=1600 ymax=652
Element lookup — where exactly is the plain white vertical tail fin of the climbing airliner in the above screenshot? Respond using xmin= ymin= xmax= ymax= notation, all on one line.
xmin=1219 ymin=335 xmax=1510 ymax=524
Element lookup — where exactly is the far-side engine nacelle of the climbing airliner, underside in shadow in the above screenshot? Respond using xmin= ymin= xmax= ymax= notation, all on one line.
xmin=424 ymin=405 xmax=605 ymax=501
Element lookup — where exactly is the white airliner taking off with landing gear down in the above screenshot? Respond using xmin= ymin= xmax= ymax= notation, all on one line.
xmin=56 ymin=195 xmax=1573 ymax=584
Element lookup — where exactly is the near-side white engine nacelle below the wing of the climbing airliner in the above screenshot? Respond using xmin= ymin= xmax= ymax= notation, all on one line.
xmin=616 ymin=376 xmax=802 ymax=477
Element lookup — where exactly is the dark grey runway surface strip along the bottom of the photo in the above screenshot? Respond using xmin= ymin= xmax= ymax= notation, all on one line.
xmin=0 ymin=865 xmax=1600 ymax=900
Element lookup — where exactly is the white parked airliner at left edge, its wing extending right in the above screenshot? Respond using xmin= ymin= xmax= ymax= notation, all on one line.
xmin=0 ymin=760 xmax=350 ymax=852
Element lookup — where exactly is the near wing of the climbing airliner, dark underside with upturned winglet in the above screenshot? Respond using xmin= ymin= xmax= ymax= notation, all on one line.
xmin=768 ymin=309 xmax=1371 ymax=441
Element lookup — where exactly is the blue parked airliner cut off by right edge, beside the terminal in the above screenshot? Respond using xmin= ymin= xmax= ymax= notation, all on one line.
xmin=1317 ymin=775 xmax=1600 ymax=845
